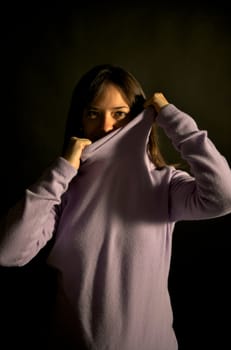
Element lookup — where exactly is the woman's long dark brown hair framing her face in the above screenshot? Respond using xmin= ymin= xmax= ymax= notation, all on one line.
xmin=63 ymin=64 xmax=166 ymax=169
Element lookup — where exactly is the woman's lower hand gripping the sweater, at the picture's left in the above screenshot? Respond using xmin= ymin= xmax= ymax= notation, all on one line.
xmin=63 ymin=136 xmax=92 ymax=169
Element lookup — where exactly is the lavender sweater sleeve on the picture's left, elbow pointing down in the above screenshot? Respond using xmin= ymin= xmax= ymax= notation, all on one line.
xmin=0 ymin=157 xmax=77 ymax=266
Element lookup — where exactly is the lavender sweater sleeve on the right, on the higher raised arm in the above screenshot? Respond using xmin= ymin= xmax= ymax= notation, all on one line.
xmin=157 ymin=104 xmax=231 ymax=221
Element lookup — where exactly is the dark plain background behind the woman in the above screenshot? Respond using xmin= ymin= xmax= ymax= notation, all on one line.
xmin=0 ymin=1 xmax=231 ymax=350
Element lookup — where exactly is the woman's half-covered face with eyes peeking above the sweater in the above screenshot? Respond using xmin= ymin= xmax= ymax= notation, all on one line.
xmin=83 ymin=84 xmax=130 ymax=142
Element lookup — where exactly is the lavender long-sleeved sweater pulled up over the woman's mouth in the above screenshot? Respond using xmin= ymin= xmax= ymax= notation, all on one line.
xmin=0 ymin=104 xmax=231 ymax=350
